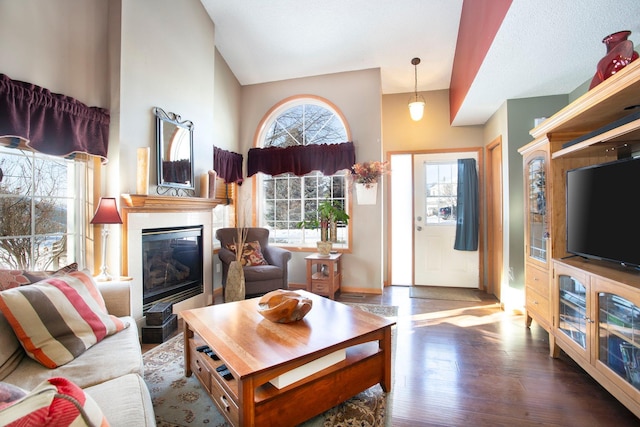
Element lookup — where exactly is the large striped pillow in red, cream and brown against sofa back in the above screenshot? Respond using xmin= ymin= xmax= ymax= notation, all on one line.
xmin=0 ymin=271 xmax=129 ymax=368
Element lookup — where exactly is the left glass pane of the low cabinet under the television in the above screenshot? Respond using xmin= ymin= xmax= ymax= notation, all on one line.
xmin=558 ymin=275 xmax=589 ymax=350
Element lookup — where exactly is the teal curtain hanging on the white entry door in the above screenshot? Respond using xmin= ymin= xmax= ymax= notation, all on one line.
xmin=453 ymin=159 xmax=479 ymax=251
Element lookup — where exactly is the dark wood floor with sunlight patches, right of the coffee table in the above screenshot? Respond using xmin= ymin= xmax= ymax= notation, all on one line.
xmin=143 ymin=286 xmax=640 ymax=427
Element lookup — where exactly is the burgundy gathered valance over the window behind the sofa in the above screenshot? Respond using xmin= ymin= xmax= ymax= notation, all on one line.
xmin=0 ymin=74 xmax=110 ymax=163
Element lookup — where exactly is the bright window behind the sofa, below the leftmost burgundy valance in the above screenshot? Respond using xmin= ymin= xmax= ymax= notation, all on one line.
xmin=0 ymin=148 xmax=80 ymax=270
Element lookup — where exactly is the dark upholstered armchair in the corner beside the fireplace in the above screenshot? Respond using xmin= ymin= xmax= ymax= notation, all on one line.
xmin=216 ymin=227 xmax=291 ymax=298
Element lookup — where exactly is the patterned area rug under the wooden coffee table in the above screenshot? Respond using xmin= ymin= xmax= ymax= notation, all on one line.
xmin=143 ymin=303 xmax=398 ymax=427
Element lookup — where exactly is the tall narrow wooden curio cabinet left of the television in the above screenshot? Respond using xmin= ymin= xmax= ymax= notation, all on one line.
xmin=519 ymin=138 xmax=552 ymax=332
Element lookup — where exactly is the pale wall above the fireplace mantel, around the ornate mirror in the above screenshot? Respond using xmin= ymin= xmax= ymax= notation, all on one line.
xmin=119 ymin=0 xmax=215 ymax=193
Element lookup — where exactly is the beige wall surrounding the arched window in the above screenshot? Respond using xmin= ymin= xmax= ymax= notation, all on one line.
xmin=239 ymin=69 xmax=383 ymax=293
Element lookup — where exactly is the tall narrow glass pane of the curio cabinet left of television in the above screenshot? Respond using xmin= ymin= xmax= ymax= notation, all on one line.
xmin=526 ymin=156 xmax=549 ymax=262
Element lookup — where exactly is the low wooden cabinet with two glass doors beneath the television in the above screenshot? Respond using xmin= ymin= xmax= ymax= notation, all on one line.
xmin=553 ymin=258 xmax=640 ymax=416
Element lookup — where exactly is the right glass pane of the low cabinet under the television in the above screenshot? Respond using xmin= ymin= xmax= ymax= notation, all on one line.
xmin=598 ymin=292 xmax=640 ymax=390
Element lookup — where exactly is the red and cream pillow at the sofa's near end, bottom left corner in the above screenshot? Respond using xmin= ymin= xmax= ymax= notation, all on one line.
xmin=0 ymin=377 xmax=109 ymax=427
